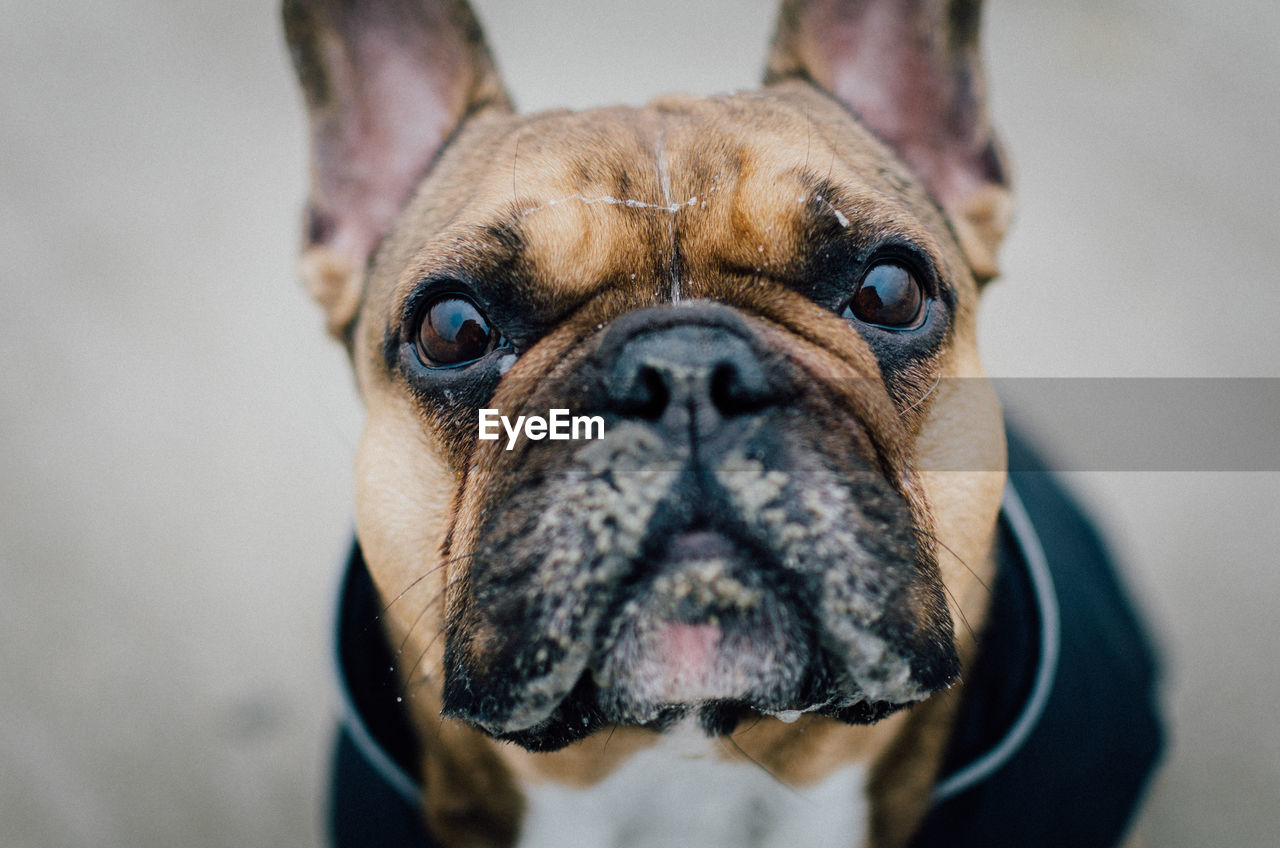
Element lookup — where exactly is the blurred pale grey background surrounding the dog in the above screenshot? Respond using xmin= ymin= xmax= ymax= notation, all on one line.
xmin=0 ymin=0 xmax=1280 ymax=848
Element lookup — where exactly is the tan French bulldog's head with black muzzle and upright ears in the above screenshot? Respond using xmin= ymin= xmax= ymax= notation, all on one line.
xmin=285 ymin=0 xmax=1007 ymax=749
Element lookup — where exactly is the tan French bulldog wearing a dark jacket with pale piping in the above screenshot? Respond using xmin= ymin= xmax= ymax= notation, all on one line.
xmin=284 ymin=0 xmax=1160 ymax=848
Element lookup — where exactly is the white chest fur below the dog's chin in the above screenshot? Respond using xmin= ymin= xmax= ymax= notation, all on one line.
xmin=518 ymin=729 xmax=867 ymax=848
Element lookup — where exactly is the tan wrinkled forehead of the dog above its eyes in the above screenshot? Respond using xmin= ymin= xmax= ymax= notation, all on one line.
xmin=371 ymin=87 xmax=951 ymax=315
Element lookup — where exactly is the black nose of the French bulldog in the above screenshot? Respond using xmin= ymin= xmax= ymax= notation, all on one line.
xmin=602 ymin=304 xmax=778 ymax=437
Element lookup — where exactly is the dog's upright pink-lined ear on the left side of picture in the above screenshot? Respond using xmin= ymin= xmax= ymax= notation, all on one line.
xmin=283 ymin=0 xmax=511 ymax=339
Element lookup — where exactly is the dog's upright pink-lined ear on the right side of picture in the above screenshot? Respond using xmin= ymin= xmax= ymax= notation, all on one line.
xmin=765 ymin=0 xmax=1012 ymax=281
